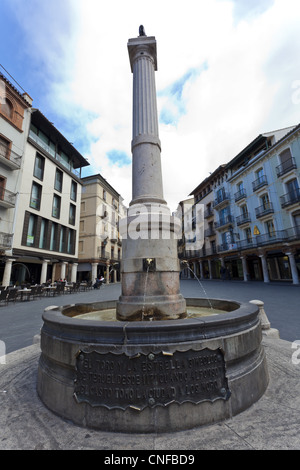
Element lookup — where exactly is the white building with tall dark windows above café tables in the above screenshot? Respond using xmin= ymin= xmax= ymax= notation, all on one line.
xmin=0 ymin=70 xmax=89 ymax=286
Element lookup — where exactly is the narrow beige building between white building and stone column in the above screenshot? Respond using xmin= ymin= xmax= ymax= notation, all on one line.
xmin=78 ymin=174 xmax=126 ymax=283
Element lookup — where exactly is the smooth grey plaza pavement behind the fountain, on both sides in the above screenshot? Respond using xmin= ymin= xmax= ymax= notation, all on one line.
xmin=0 ymin=280 xmax=300 ymax=353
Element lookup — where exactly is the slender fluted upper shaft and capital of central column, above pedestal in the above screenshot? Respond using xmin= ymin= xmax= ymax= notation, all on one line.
xmin=128 ymin=37 xmax=166 ymax=205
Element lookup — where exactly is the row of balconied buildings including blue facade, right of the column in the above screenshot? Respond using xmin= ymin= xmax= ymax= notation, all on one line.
xmin=183 ymin=126 xmax=300 ymax=284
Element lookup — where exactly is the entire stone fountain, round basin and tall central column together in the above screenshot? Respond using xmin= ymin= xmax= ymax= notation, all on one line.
xmin=37 ymin=27 xmax=268 ymax=433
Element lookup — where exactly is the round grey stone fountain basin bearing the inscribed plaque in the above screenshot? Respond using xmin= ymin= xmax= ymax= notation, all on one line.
xmin=37 ymin=299 xmax=268 ymax=433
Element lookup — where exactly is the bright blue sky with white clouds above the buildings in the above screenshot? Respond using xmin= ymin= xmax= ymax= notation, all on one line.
xmin=0 ymin=0 xmax=300 ymax=210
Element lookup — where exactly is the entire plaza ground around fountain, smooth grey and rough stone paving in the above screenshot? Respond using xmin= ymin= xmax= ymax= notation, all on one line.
xmin=0 ymin=280 xmax=300 ymax=455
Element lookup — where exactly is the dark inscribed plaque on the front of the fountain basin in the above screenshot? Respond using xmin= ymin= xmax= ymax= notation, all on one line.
xmin=74 ymin=348 xmax=230 ymax=410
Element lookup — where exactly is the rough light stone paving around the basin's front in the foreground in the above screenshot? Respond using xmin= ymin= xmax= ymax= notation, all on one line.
xmin=0 ymin=337 xmax=300 ymax=452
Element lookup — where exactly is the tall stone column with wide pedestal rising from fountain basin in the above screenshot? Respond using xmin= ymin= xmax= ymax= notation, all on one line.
xmin=117 ymin=29 xmax=186 ymax=321
